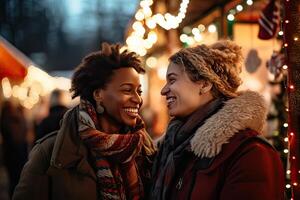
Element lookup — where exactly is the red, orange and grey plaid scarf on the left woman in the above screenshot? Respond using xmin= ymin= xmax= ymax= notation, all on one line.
xmin=78 ymin=99 xmax=155 ymax=200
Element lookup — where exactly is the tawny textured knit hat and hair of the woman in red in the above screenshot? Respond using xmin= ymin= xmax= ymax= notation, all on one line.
xmin=169 ymin=40 xmax=243 ymax=98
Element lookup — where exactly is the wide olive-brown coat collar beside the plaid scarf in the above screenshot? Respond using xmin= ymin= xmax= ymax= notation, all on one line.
xmin=48 ymin=107 xmax=96 ymax=179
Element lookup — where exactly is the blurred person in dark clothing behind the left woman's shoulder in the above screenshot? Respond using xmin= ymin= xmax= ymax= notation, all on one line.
xmin=36 ymin=89 xmax=69 ymax=140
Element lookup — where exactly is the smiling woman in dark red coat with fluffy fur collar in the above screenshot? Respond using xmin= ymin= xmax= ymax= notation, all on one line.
xmin=151 ymin=41 xmax=284 ymax=200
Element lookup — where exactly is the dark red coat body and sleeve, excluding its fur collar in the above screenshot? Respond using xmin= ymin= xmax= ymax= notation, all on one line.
xmin=170 ymin=130 xmax=284 ymax=200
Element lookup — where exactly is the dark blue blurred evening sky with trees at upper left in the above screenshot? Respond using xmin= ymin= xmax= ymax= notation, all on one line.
xmin=0 ymin=0 xmax=139 ymax=75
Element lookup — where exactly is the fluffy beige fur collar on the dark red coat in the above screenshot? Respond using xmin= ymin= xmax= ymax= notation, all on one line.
xmin=191 ymin=91 xmax=267 ymax=158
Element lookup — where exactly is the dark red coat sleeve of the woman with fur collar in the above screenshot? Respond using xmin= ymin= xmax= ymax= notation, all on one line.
xmin=220 ymin=142 xmax=284 ymax=200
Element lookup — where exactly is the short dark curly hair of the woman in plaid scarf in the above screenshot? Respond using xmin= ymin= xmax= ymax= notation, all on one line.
xmin=70 ymin=43 xmax=145 ymax=103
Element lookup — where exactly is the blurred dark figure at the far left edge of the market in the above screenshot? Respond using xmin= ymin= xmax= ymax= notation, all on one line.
xmin=0 ymin=100 xmax=29 ymax=197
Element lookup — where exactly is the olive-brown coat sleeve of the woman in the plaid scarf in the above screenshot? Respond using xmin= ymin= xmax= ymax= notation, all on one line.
xmin=13 ymin=144 xmax=49 ymax=200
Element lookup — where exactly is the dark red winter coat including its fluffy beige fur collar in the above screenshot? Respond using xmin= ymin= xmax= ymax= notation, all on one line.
xmin=152 ymin=91 xmax=284 ymax=200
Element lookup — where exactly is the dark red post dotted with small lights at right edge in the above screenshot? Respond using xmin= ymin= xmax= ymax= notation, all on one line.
xmin=283 ymin=0 xmax=300 ymax=200
